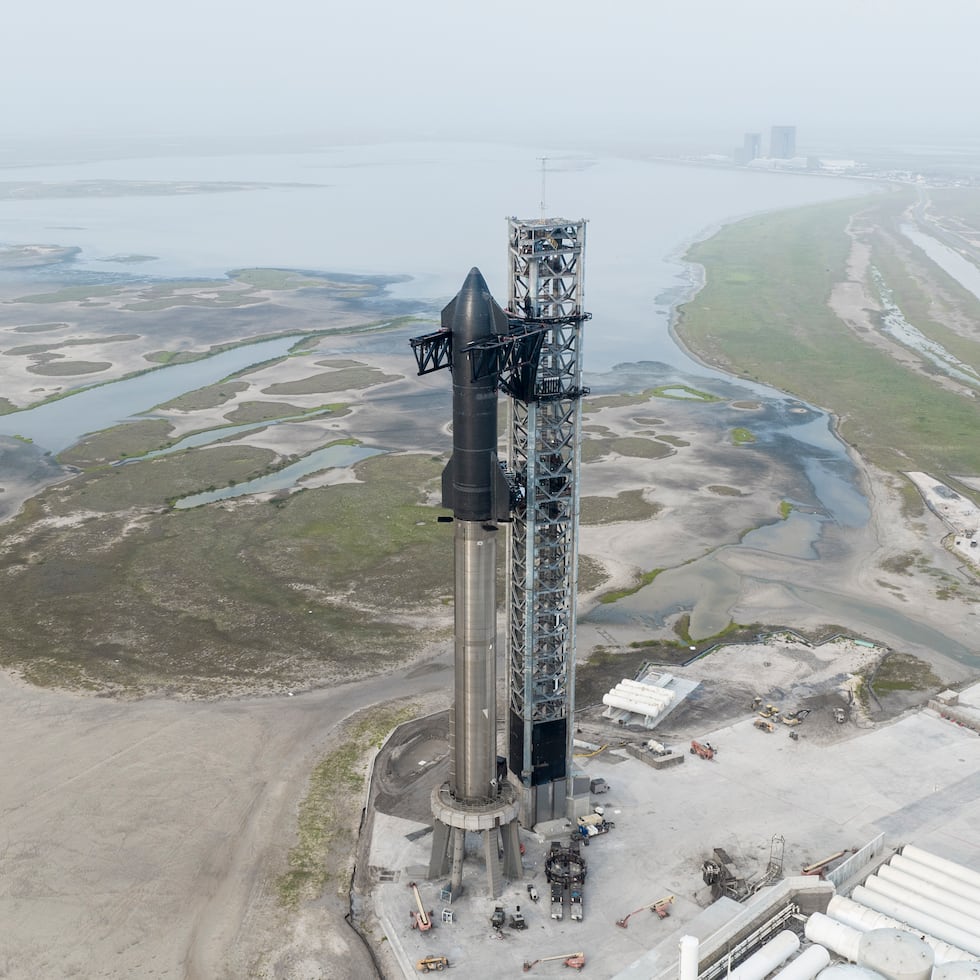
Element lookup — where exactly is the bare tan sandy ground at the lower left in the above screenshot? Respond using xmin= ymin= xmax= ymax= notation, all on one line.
xmin=0 ymin=648 xmax=447 ymax=980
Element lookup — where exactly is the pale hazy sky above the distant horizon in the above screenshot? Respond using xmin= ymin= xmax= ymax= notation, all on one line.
xmin=7 ymin=0 xmax=980 ymax=148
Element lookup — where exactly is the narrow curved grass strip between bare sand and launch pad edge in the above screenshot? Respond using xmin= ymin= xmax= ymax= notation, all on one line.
xmin=276 ymin=705 xmax=418 ymax=910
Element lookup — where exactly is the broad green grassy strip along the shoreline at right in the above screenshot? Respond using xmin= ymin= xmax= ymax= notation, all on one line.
xmin=677 ymin=192 xmax=980 ymax=474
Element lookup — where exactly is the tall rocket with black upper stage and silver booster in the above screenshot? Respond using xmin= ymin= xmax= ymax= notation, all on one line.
xmin=442 ymin=268 xmax=510 ymax=803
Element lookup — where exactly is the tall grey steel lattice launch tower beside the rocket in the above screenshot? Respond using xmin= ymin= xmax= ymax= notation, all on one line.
xmin=507 ymin=218 xmax=590 ymax=823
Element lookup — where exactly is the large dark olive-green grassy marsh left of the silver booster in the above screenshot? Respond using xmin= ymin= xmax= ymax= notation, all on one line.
xmin=0 ymin=454 xmax=452 ymax=696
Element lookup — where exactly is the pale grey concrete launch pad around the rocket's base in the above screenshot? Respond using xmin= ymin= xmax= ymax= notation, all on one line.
xmin=360 ymin=685 xmax=980 ymax=978
